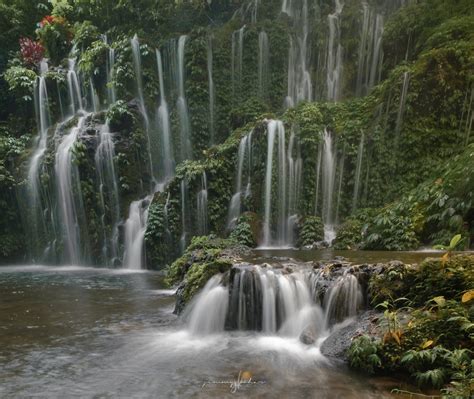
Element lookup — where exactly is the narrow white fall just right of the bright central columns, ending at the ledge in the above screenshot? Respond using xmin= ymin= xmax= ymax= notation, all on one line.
xmin=322 ymin=129 xmax=336 ymax=244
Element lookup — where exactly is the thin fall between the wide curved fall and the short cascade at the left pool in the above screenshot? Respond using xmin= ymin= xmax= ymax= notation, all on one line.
xmin=95 ymin=123 xmax=120 ymax=265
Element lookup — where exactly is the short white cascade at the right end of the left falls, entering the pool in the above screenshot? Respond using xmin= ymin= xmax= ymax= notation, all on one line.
xmin=123 ymin=195 xmax=153 ymax=270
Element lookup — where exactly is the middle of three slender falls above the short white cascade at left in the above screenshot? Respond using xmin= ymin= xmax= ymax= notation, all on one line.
xmin=156 ymin=50 xmax=175 ymax=182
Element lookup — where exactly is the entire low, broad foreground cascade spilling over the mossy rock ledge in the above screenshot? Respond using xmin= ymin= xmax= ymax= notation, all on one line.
xmin=184 ymin=264 xmax=362 ymax=339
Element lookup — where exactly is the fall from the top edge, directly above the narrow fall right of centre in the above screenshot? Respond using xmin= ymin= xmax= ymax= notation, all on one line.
xmin=326 ymin=0 xmax=344 ymax=101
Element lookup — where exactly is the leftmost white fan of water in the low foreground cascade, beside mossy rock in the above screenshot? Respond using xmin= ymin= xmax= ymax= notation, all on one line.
xmin=184 ymin=275 xmax=229 ymax=335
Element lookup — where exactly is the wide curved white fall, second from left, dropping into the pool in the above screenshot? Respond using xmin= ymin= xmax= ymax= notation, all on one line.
xmin=55 ymin=116 xmax=87 ymax=264
